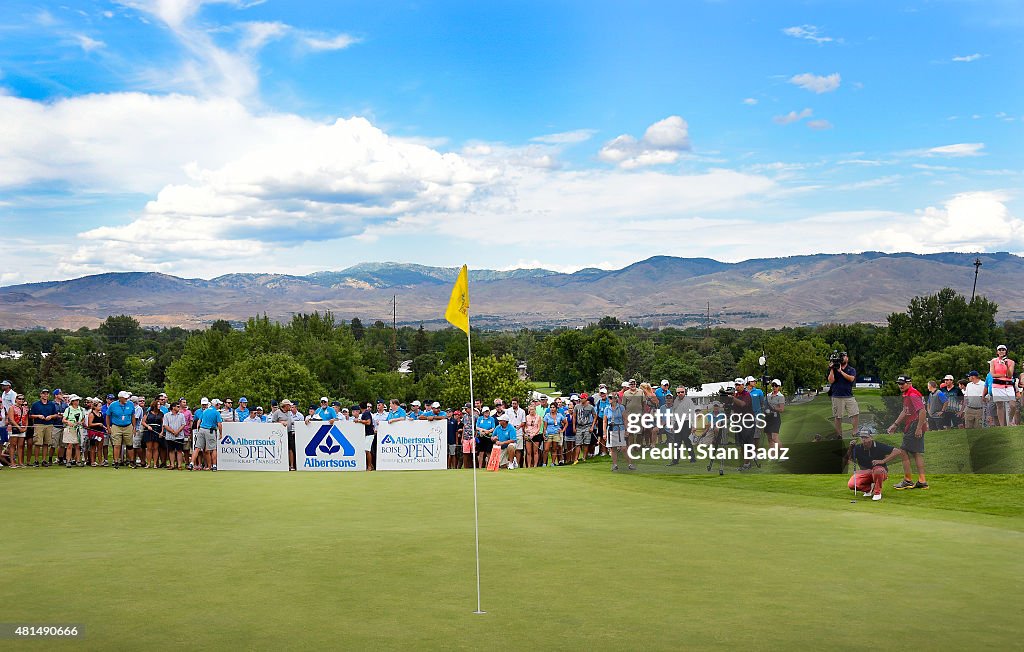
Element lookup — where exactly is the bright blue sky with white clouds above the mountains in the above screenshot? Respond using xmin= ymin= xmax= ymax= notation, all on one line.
xmin=0 ymin=0 xmax=1024 ymax=285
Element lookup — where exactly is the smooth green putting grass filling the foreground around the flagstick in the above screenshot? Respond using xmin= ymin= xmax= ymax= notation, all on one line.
xmin=0 ymin=459 xmax=1024 ymax=650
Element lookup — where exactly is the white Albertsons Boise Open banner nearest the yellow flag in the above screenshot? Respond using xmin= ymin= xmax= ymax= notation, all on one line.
xmin=377 ymin=421 xmax=447 ymax=471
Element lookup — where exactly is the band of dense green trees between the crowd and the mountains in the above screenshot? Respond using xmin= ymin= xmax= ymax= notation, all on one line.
xmin=0 ymin=289 xmax=1007 ymax=404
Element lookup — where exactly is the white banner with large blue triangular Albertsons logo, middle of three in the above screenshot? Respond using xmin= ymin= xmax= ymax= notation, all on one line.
xmin=295 ymin=421 xmax=367 ymax=471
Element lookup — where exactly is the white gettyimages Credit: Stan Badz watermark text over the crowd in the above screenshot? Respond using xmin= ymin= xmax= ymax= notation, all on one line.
xmin=626 ymin=410 xmax=790 ymax=463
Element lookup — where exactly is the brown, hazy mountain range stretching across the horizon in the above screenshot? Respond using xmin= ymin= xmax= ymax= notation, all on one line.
xmin=0 ymin=252 xmax=1024 ymax=329
